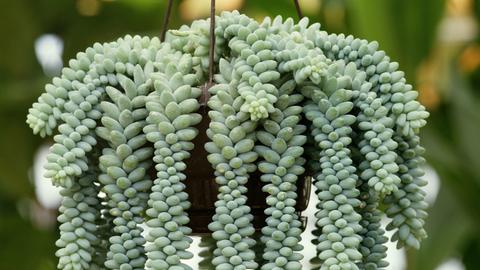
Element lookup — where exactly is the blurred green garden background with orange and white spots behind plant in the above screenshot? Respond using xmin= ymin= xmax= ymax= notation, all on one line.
xmin=0 ymin=0 xmax=480 ymax=270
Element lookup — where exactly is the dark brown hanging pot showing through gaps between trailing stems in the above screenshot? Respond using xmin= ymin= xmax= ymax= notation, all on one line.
xmin=180 ymin=107 xmax=311 ymax=233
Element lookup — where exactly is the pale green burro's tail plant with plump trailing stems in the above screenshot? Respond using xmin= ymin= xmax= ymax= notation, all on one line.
xmin=27 ymin=12 xmax=428 ymax=270
